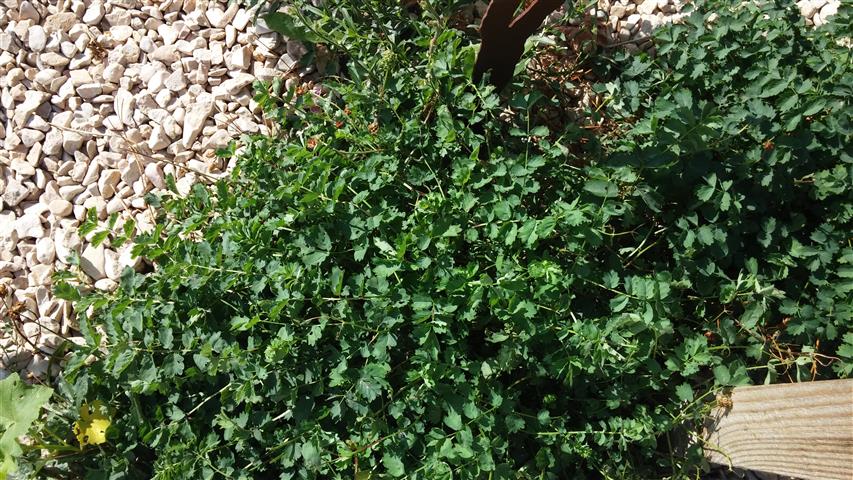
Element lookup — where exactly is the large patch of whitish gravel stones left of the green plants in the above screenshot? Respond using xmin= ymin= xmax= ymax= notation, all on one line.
xmin=0 ymin=0 xmax=306 ymax=378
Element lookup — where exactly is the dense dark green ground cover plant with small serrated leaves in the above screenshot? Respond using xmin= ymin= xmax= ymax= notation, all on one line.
xmin=10 ymin=0 xmax=853 ymax=480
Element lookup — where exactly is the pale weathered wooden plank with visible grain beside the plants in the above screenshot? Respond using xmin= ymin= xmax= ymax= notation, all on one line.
xmin=705 ymin=379 xmax=853 ymax=480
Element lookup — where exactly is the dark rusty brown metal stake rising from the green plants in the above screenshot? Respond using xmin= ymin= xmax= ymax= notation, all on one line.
xmin=474 ymin=0 xmax=563 ymax=90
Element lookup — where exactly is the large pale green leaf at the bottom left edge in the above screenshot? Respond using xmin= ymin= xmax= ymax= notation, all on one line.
xmin=0 ymin=373 xmax=53 ymax=479
